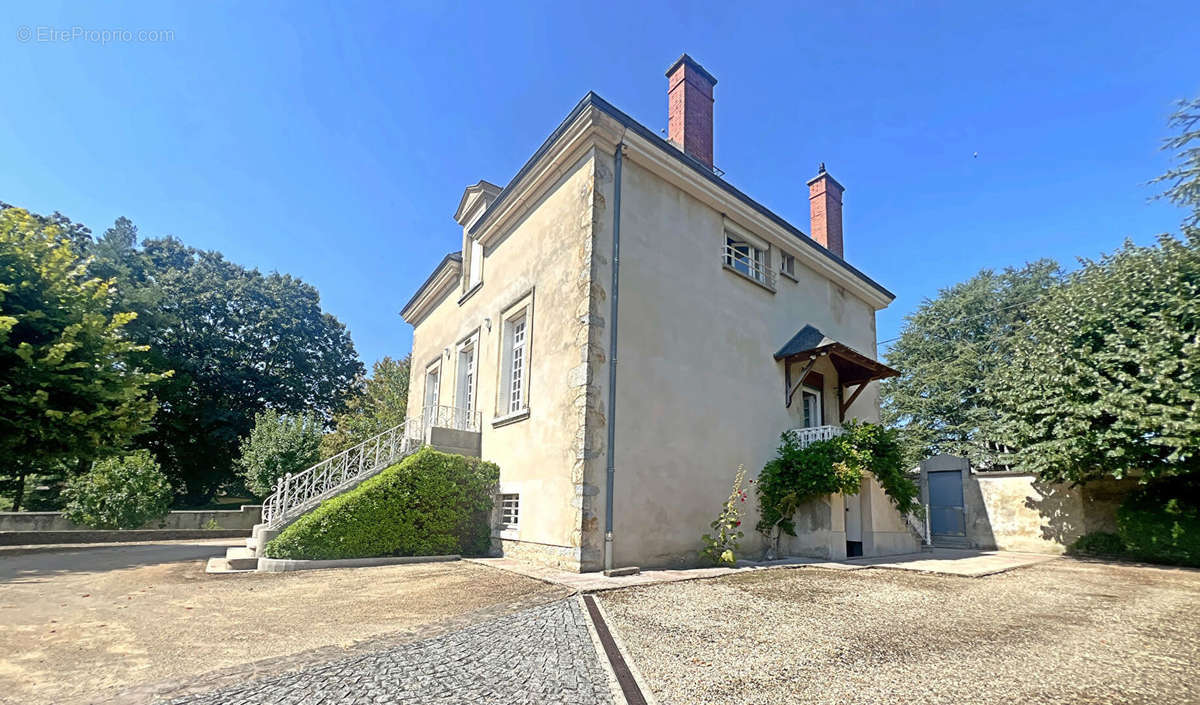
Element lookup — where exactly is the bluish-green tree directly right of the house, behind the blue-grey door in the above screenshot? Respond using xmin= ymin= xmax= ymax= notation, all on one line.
xmin=882 ymin=260 xmax=1061 ymax=468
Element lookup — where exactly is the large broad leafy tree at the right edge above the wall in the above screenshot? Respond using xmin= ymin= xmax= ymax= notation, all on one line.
xmin=990 ymin=228 xmax=1200 ymax=482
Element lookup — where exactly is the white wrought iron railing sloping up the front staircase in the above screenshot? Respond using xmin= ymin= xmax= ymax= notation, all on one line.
xmin=263 ymin=418 xmax=424 ymax=529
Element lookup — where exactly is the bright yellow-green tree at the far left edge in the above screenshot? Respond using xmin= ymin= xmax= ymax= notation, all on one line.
xmin=0 ymin=207 xmax=169 ymax=511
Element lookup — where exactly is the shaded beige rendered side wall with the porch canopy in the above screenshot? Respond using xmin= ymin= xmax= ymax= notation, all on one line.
xmin=614 ymin=159 xmax=899 ymax=566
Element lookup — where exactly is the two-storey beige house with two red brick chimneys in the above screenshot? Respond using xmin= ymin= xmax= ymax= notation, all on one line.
xmin=402 ymin=55 xmax=918 ymax=571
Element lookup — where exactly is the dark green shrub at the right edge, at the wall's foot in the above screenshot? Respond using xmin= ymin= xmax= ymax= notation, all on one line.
xmin=1117 ymin=477 xmax=1200 ymax=566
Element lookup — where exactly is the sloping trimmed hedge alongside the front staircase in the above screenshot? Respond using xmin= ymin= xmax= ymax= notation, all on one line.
xmin=265 ymin=447 xmax=500 ymax=560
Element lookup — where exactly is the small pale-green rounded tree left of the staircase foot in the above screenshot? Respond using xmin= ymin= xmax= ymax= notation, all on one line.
xmin=238 ymin=410 xmax=320 ymax=496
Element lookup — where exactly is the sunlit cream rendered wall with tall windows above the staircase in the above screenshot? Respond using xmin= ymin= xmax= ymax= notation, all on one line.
xmin=409 ymin=151 xmax=602 ymax=570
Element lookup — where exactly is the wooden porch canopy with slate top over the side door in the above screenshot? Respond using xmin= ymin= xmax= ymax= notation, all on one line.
xmin=775 ymin=325 xmax=900 ymax=421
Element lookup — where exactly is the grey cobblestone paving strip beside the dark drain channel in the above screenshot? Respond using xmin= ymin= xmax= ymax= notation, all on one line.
xmin=161 ymin=598 xmax=612 ymax=705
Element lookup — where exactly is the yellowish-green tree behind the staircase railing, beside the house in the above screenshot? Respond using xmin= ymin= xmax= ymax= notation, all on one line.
xmin=320 ymin=356 xmax=412 ymax=457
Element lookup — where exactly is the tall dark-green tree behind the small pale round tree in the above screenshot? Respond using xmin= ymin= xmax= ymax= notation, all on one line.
xmin=91 ymin=231 xmax=362 ymax=505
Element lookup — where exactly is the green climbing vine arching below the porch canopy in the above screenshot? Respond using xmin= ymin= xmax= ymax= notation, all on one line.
xmin=755 ymin=421 xmax=922 ymax=549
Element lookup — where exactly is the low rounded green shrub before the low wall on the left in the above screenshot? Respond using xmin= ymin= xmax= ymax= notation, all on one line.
xmin=62 ymin=451 xmax=174 ymax=529
